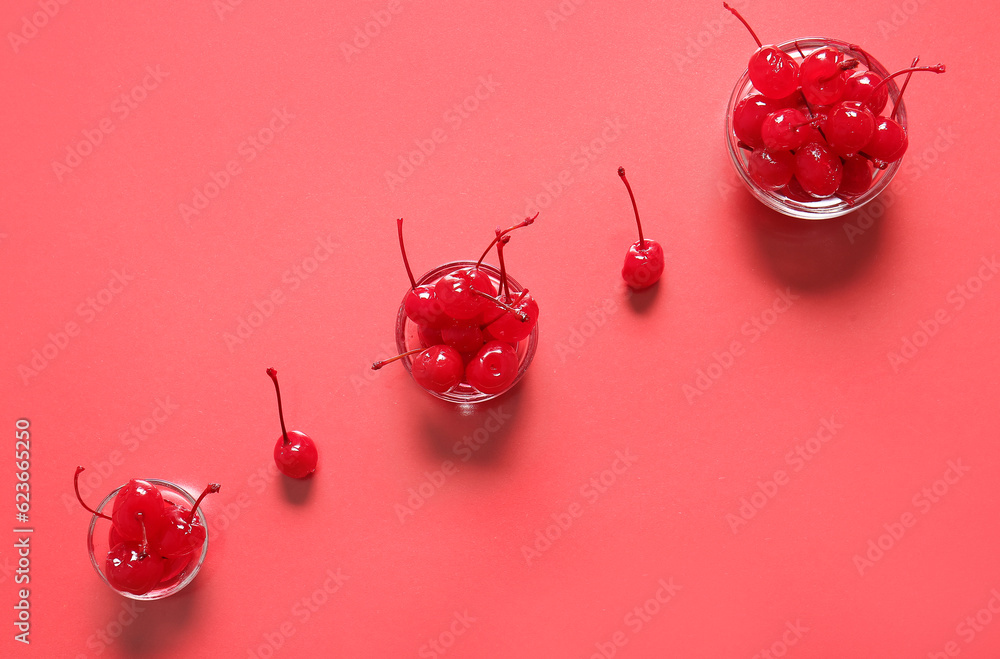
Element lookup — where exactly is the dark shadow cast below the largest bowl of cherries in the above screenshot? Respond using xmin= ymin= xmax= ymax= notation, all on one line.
xmin=738 ymin=193 xmax=894 ymax=293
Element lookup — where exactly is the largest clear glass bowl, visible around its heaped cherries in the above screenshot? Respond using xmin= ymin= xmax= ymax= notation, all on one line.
xmin=726 ymin=37 xmax=906 ymax=220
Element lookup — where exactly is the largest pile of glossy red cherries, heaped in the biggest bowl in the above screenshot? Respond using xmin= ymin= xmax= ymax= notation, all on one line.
xmin=723 ymin=3 xmax=945 ymax=202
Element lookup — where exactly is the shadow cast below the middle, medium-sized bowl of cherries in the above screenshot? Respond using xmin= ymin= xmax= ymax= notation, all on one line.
xmin=421 ymin=373 xmax=531 ymax=467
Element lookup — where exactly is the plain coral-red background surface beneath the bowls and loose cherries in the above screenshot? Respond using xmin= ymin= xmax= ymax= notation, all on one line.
xmin=0 ymin=0 xmax=1000 ymax=658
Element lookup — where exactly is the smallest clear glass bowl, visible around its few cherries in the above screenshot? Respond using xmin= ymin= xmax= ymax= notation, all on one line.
xmin=87 ymin=478 xmax=208 ymax=601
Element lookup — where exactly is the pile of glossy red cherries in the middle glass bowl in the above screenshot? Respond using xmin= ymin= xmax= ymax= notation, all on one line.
xmin=372 ymin=219 xmax=538 ymax=394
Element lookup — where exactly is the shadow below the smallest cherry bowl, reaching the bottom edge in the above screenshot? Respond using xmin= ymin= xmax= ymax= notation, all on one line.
xmin=114 ymin=579 xmax=202 ymax=657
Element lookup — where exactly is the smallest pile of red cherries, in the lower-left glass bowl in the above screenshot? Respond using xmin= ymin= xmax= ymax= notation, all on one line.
xmin=73 ymin=467 xmax=219 ymax=595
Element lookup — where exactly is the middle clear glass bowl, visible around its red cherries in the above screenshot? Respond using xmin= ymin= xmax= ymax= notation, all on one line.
xmin=396 ymin=261 xmax=538 ymax=404
